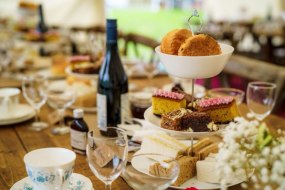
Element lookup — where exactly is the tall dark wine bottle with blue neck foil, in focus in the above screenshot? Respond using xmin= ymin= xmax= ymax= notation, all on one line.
xmin=97 ymin=19 xmax=129 ymax=136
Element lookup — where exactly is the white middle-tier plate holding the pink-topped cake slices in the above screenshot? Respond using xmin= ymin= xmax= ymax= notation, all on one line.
xmin=144 ymin=107 xmax=226 ymax=139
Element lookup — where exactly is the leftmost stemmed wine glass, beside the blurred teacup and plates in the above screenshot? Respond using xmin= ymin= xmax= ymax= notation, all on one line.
xmin=22 ymin=75 xmax=48 ymax=131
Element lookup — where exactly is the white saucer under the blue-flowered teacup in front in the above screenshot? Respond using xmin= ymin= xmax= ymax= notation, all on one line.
xmin=10 ymin=173 xmax=93 ymax=190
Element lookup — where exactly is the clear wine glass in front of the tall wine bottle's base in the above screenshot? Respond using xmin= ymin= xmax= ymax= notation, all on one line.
xmin=87 ymin=127 xmax=128 ymax=189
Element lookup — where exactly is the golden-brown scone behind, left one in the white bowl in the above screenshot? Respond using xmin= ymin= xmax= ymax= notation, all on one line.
xmin=160 ymin=29 xmax=192 ymax=55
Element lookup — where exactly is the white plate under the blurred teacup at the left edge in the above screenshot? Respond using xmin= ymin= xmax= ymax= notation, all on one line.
xmin=0 ymin=104 xmax=35 ymax=125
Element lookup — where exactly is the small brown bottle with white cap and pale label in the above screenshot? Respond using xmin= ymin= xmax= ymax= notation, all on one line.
xmin=70 ymin=109 xmax=89 ymax=155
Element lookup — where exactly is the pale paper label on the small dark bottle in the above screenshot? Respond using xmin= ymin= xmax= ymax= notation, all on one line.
xmin=70 ymin=129 xmax=87 ymax=150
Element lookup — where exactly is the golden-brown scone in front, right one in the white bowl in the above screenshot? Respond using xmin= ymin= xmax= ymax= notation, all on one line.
xmin=178 ymin=34 xmax=221 ymax=56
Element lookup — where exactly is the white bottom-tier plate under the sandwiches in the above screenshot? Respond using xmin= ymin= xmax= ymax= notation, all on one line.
xmin=131 ymin=151 xmax=248 ymax=190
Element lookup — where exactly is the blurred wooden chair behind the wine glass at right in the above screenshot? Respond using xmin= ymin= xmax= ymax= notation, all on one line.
xmin=221 ymin=55 xmax=285 ymax=109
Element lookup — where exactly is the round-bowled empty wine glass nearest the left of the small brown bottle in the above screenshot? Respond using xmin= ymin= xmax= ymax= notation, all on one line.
xmin=47 ymin=81 xmax=76 ymax=135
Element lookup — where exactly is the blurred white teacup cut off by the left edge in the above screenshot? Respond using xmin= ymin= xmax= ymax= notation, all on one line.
xmin=0 ymin=88 xmax=21 ymax=118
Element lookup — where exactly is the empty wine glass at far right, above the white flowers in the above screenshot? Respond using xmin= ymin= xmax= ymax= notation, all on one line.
xmin=246 ymin=82 xmax=277 ymax=121
